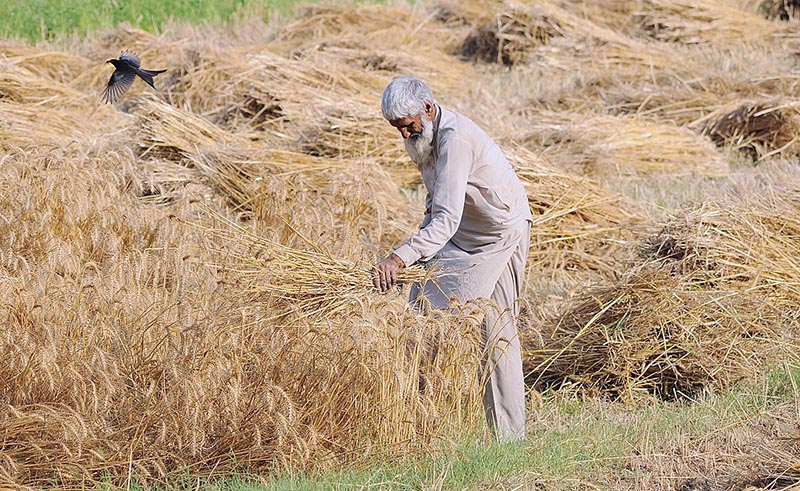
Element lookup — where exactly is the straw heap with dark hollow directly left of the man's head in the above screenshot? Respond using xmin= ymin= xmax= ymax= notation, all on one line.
xmin=172 ymin=50 xmax=412 ymax=172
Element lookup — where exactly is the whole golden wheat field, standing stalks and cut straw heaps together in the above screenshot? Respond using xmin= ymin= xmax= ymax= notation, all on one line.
xmin=0 ymin=0 xmax=800 ymax=489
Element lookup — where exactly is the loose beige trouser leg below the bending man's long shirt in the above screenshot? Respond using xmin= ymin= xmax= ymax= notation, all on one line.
xmin=481 ymin=225 xmax=530 ymax=442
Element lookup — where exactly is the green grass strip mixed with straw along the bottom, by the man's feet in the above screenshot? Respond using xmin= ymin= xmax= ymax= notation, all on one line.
xmin=142 ymin=364 xmax=800 ymax=491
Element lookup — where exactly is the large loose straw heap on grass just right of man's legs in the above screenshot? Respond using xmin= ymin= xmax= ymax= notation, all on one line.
xmin=525 ymin=266 xmax=783 ymax=401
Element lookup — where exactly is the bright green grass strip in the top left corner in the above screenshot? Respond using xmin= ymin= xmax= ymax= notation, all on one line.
xmin=0 ymin=0 xmax=340 ymax=42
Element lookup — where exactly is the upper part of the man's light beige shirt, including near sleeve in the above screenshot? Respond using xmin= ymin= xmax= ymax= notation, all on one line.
xmin=394 ymin=105 xmax=532 ymax=266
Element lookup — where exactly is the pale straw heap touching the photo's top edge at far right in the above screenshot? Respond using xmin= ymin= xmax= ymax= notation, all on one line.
xmin=635 ymin=0 xmax=778 ymax=47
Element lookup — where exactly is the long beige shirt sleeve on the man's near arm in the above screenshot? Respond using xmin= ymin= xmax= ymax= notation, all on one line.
xmin=394 ymin=138 xmax=472 ymax=266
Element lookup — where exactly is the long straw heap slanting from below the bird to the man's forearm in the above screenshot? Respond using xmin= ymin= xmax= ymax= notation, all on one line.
xmin=136 ymin=99 xmax=415 ymax=247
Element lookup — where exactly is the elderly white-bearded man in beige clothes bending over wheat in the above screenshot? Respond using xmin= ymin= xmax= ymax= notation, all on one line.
xmin=374 ymin=76 xmax=532 ymax=441
